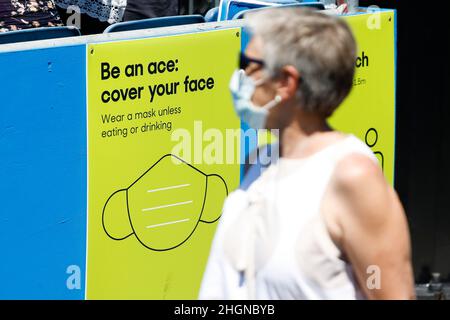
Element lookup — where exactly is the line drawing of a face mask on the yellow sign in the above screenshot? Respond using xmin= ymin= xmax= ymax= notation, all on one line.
xmin=102 ymin=154 xmax=228 ymax=251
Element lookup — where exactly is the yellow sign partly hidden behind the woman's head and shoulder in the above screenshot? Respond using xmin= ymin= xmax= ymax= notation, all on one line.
xmin=331 ymin=11 xmax=395 ymax=184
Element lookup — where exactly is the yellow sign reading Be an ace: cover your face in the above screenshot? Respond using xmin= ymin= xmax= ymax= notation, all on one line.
xmin=86 ymin=29 xmax=241 ymax=299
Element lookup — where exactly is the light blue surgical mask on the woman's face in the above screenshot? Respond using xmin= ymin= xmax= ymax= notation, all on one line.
xmin=230 ymin=70 xmax=281 ymax=129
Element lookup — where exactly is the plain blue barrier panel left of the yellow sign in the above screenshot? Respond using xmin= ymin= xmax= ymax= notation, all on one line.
xmin=0 ymin=45 xmax=86 ymax=299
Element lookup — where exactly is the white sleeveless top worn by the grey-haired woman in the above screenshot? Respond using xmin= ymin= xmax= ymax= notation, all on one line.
xmin=199 ymin=136 xmax=377 ymax=300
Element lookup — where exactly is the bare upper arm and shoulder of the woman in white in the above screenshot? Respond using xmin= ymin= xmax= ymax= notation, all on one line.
xmin=326 ymin=155 xmax=415 ymax=299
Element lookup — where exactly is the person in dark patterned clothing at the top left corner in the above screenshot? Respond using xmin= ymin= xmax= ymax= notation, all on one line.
xmin=0 ymin=0 xmax=63 ymax=32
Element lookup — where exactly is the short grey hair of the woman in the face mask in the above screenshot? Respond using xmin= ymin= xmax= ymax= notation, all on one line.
xmin=246 ymin=8 xmax=356 ymax=117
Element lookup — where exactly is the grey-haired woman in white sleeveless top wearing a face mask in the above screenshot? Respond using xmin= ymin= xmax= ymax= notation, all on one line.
xmin=200 ymin=8 xmax=414 ymax=299
